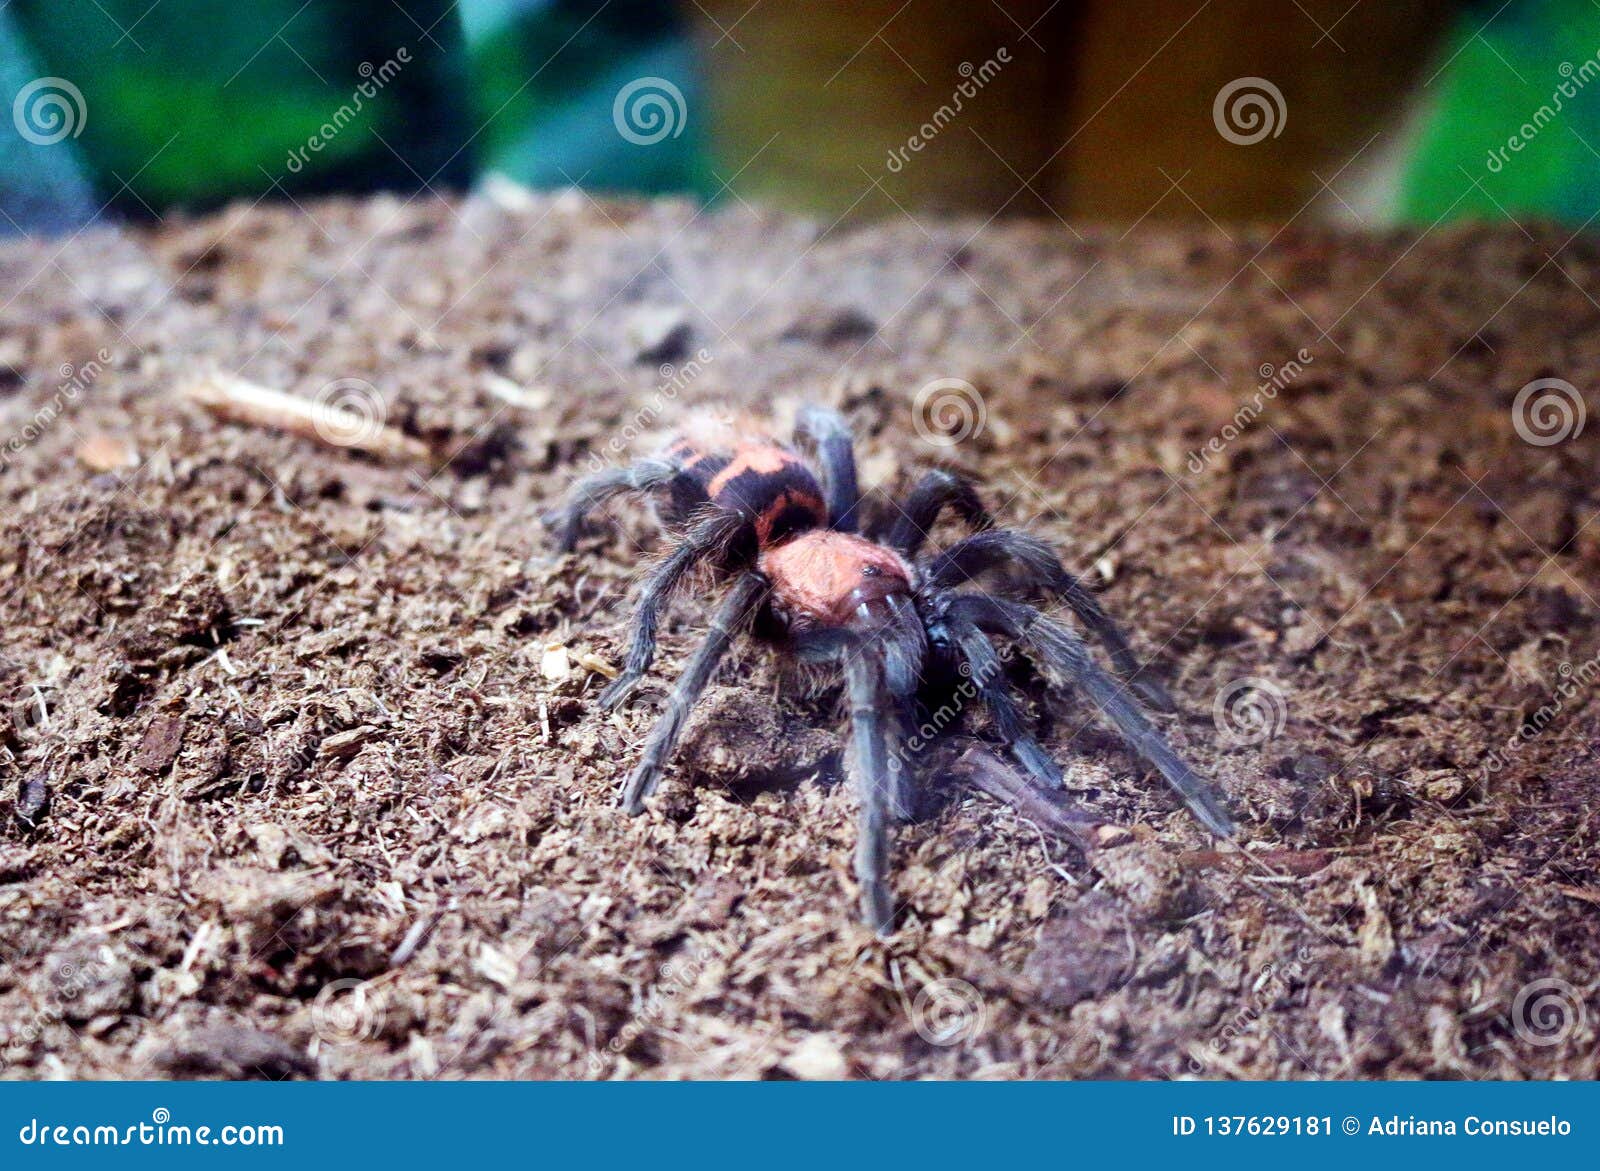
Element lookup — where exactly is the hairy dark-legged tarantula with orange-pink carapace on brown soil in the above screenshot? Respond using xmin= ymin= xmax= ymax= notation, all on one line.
xmin=544 ymin=406 xmax=1234 ymax=934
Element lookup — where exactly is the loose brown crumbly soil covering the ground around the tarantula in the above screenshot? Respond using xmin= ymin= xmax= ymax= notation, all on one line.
xmin=0 ymin=192 xmax=1600 ymax=1078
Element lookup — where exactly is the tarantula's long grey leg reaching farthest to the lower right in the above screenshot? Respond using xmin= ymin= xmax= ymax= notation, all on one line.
xmin=950 ymin=593 xmax=1234 ymax=838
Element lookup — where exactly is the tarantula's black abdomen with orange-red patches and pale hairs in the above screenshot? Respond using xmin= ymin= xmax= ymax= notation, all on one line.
xmin=667 ymin=437 xmax=827 ymax=547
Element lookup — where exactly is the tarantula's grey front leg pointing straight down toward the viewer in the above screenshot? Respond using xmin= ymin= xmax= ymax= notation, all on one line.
xmin=845 ymin=646 xmax=894 ymax=936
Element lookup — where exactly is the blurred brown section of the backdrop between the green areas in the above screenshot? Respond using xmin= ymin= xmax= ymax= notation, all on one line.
xmin=690 ymin=0 xmax=1454 ymax=219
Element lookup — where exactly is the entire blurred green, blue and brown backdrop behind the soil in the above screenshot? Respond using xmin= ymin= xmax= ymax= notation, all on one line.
xmin=0 ymin=0 xmax=1600 ymax=232
